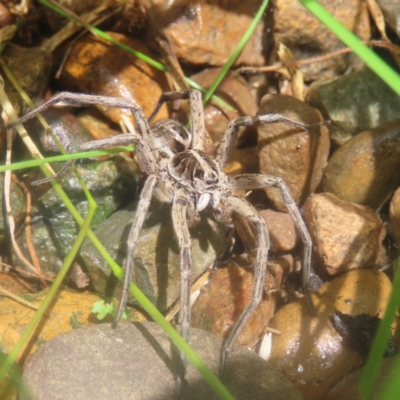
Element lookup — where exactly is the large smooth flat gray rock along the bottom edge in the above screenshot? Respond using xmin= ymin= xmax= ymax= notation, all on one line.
xmin=21 ymin=322 xmax=303 ymax=400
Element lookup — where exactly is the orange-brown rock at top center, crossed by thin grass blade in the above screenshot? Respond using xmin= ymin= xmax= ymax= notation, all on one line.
xmin=154 ymin=0 xmax=265 ymax=66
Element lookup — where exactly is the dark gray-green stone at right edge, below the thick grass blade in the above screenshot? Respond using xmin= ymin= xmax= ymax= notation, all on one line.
xmin=307 ymin=67 xmax=400 ymax=145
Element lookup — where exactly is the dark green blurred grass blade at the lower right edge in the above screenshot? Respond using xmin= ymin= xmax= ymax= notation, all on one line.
xmin=359 ymin=258 xmax=400 ymax=400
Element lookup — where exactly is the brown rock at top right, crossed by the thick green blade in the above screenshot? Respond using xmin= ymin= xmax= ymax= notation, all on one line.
xmin=273 ymin=0 xmax=371 ymax=80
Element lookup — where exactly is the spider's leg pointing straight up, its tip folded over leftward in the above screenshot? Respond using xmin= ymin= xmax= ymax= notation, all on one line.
xmin=149 ymin=89 xmax=205 ymax=150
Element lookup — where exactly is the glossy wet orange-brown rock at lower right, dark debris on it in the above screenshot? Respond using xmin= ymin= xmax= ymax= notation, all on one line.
xmin=269 ymin=270 xmax=391 ymax=400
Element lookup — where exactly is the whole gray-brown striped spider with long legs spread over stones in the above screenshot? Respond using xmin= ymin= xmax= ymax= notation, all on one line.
xmin=8 ymin=89 xmax=321 ymax=374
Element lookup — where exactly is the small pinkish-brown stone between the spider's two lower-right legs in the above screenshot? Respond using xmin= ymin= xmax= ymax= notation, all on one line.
xmin=260 ymin=210 xmax=298 ymax=252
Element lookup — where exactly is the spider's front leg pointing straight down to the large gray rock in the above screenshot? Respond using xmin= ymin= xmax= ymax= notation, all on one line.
xmin=172 ymin=189 xmax=192 ymax=376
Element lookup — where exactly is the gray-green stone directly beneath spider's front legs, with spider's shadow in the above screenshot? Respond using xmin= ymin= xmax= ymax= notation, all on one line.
xmin=80 ymin=200 xmax=225 ymax=311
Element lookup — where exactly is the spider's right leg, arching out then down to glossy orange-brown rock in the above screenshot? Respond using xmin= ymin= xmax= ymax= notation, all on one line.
xmin=227 ymin=174 xmax=317 ymax=317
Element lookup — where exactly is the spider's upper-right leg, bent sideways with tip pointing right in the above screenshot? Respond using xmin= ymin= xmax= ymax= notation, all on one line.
xmin=215 ymin=114 xmax=327 ymax=170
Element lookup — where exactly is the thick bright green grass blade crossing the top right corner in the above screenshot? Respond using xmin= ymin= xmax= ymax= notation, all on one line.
xmin=300 ymin=0 xmax=400 ymax=95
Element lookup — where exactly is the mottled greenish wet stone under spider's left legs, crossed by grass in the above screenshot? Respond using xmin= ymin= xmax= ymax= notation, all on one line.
xmin=13 ymin=156 xmax=139 ymax=274
